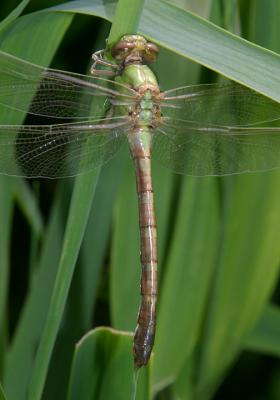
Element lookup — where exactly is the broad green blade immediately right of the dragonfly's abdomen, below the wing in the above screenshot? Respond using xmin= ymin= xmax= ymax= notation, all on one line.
xmin=153 ymin=178 xmax=218 ymax=388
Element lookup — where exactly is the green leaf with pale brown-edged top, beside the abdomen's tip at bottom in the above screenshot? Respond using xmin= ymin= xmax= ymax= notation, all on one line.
xmin=68 ymin=328 xmax=151 ymax=400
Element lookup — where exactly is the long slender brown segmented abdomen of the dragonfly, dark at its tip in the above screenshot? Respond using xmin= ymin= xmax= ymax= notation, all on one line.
xmin=129 ymin=127 xmax=157 ymax=367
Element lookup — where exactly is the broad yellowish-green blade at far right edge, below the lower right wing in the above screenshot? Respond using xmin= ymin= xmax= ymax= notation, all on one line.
xmin=197 ymin=172 xmax=280 ymax=398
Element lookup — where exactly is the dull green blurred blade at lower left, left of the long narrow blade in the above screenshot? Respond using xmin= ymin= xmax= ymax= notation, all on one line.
xmin=4 ymin=185 xmax=67 ymax=400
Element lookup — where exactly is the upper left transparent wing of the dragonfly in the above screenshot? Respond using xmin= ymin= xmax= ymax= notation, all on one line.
xmin=0 ymin=51 xmax=135 ymax=119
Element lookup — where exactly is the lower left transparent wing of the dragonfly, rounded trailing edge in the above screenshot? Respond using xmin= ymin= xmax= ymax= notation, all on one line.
xmin=0 ymin=118 xmax=129 ymax=178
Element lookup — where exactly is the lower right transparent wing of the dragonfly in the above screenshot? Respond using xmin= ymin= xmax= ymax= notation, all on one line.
xmin=153 ymin=121 xmax=280 ymax=176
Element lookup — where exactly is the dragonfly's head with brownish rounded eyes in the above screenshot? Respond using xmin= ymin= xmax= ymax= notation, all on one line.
xmin=111 ymin=35 xmax=159 ymax=66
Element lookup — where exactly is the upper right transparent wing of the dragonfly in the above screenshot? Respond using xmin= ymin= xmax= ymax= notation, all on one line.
xmin=161 ymin=82 xmax=280 ymax=126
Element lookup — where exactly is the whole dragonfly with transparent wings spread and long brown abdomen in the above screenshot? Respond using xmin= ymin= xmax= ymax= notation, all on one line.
xmin=0 ymin=35 xmax=280 ymax=368
